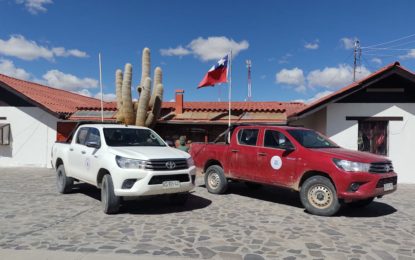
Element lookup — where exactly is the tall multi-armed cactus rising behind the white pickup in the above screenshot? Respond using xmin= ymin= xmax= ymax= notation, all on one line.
xmin=116 ymin=48 xmax=164 ymax=127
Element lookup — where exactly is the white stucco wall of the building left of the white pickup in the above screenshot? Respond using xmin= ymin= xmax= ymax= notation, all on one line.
xmin=0 ymin=106 xmax=58 ymax=167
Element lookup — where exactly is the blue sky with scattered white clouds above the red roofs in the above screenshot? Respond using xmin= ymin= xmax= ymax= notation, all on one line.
xmin=0 ymin=0 xmax=415 ymax=102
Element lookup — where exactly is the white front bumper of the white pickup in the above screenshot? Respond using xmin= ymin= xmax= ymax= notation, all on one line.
xmin=111 ymin=166 xmax=196 ymax=197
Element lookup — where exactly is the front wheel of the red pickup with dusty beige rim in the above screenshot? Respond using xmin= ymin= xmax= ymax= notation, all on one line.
xmin=300 ymin=176 xmax=341 ymax=216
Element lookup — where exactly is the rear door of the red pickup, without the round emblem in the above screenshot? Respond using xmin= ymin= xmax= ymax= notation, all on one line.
xmin=230 ymin=128 xmax=259 ymax=180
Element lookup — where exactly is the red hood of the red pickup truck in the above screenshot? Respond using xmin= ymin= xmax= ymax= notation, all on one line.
xmin=310 ymin=148 xmax=390 ymax=163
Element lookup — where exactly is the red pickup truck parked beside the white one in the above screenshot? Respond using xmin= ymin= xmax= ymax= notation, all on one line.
xmin=191 ymin=125 xmax=397 ymax=216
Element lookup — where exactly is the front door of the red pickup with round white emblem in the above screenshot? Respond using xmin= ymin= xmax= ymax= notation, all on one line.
xmin=255 ymin=129 xmax=297 ymax=186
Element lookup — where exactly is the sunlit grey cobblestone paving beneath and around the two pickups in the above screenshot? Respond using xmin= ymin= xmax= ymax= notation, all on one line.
xmin=0 ymin=168 xmax=415 ymax=259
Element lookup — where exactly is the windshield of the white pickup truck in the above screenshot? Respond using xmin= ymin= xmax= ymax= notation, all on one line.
xmin=104 ymin=128 xmax=166 ymax=146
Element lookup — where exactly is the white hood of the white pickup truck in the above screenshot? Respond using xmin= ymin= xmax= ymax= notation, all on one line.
xmin=109 ymin=146 xmax=190 ymax=160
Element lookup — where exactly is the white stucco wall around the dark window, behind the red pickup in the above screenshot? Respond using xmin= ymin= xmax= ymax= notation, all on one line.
xmin=326 ymin=103 xmax=415 ymax=183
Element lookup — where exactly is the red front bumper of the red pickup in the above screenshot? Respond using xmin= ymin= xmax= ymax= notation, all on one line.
xmin=337 ymin=172 xmax=398 ymax=202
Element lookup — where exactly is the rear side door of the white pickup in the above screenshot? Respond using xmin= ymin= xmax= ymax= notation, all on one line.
xmin=65 ymin=127 xmax=89 ymax=180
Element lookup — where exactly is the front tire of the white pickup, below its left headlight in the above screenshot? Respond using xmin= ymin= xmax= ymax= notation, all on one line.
xmin=101 ymin=174 xmax=121 ymax=214
